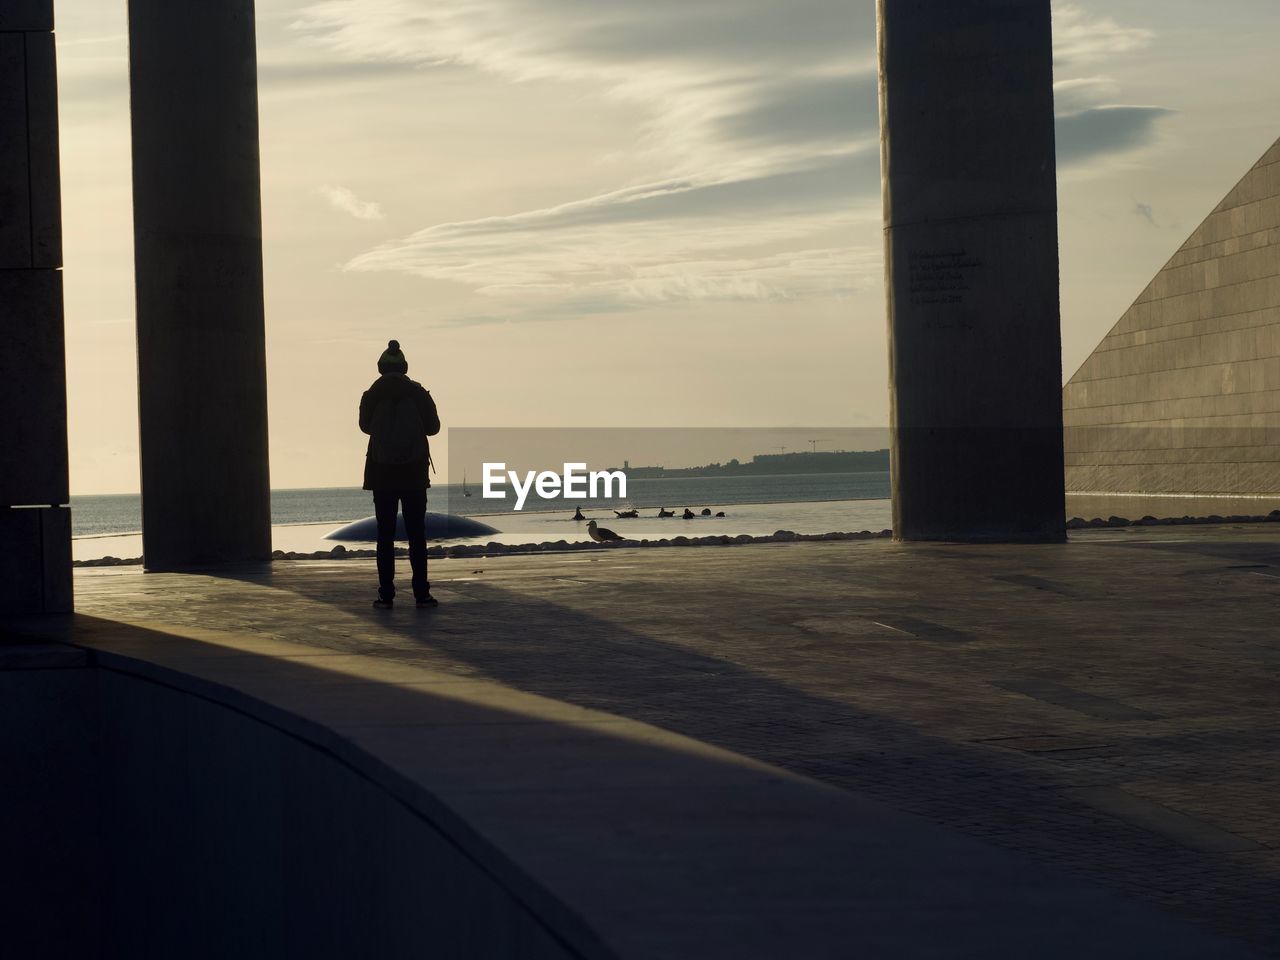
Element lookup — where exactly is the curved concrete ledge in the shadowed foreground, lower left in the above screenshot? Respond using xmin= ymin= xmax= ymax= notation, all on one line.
xmin=0 ymin=617 xmax=1248 ymax=960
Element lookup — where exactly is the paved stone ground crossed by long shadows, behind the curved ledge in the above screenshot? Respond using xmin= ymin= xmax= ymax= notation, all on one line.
xmin=77 ymin=525 xmax=1280 ymax=956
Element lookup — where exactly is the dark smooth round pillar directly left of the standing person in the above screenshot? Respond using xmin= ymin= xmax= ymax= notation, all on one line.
xmin=129 ymin=0 xmax=271 ymax=570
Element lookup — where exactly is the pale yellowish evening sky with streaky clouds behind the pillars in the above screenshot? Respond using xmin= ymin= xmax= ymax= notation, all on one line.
xmin=49 ymin=0 xmax=1280 ymax=494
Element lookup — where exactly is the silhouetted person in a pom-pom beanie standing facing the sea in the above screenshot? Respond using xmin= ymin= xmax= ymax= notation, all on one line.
xmin=360 ymin=340 xmax=440 ymax=609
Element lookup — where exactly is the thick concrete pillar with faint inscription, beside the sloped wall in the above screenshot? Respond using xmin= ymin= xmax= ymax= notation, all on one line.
xmin=878 ymin=0 xmax=1065 ymax=543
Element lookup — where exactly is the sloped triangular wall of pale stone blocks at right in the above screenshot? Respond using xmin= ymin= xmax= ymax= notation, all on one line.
xmin=1062 ymin=135 xmax=1280 ymax=497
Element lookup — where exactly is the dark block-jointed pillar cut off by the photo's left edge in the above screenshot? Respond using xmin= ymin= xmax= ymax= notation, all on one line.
xmin=0 ymin=0 xmax=72 ymax=613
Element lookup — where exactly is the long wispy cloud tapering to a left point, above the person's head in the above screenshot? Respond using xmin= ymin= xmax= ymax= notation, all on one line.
xmin=348 ymin=151 xmax=879 ymax=311
